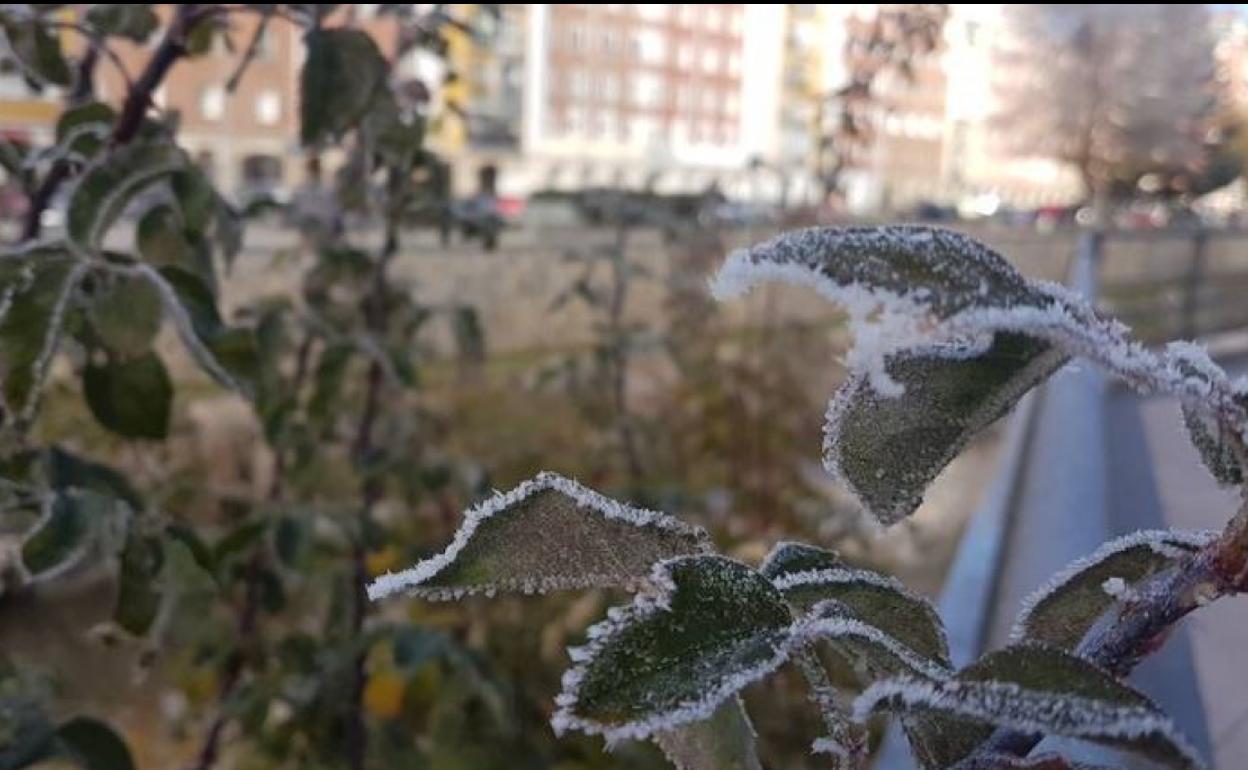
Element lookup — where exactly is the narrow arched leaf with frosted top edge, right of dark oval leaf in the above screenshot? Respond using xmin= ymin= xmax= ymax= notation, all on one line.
xmin=773 ymin=568 xmax=950 ymax=668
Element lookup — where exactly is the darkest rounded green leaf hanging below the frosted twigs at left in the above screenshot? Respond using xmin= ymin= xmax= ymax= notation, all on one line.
xmin=82 ymin=353 xmax=173 ymax=439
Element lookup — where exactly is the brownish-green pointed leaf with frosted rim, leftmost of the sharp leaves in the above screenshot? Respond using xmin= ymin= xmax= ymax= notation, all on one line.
xmin=368 ymin=473 xmax=709 ymax=600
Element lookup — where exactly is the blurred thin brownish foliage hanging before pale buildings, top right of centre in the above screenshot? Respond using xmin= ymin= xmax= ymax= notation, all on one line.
xmin=815 ymin=2 xmax=948 ymax=195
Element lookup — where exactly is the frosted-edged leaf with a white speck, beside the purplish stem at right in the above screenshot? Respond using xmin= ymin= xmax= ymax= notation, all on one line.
xmin=1011 ymin=530 xmax=1216 ymax=650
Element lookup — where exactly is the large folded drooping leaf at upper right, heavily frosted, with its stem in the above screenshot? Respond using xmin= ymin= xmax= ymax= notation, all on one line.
xmin=713 ymin=226 xmax=1248 ymax=523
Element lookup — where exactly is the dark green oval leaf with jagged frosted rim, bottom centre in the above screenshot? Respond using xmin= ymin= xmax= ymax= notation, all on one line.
xmin=553 ymin=555 xmax=792 ymax=740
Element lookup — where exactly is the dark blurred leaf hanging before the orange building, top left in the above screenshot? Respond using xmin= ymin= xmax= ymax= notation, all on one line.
xmin=300 ymin=27 xmax=389 ymax=145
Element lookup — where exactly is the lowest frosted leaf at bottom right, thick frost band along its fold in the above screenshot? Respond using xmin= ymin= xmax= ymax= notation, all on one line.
xmin=854 ymin=644 xmax=1203 ymax=770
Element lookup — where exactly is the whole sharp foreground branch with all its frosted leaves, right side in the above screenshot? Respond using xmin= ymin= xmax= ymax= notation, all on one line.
xmin=369 ymin=226 xmax=1248 ymax=770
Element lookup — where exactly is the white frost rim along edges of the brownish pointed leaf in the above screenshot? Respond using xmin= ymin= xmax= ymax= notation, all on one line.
xmin=368 ymin=472 xmax=709 ymax=604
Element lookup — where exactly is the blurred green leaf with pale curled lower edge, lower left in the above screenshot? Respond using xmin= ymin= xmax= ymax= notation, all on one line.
xmin=21 ymin=490 xmax=119 ymax=580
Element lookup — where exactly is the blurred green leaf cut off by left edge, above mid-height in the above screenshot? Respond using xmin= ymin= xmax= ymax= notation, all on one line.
xmin=0 ymin=255 xmax=86 ymax=422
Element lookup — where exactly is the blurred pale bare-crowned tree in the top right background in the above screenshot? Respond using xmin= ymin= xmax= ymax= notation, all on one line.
xmin=997 ymin=4 xmax=1217 ymax=201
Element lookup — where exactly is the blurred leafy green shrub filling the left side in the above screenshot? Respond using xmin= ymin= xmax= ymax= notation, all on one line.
xmin=0 ymin=4 xmax=497 ymax=770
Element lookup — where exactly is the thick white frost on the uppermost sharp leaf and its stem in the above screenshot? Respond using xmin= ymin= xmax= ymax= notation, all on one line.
xmin=711 ymin=227 xmax=1248 ymax=497
